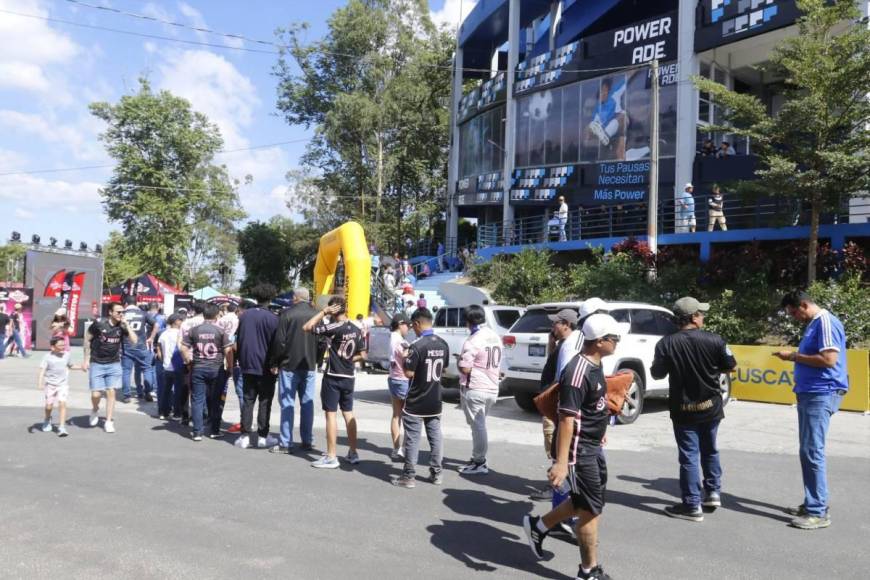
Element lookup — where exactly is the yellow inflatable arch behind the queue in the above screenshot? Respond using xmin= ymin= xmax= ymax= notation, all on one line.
xmin=314 ymin=222 xmax=372 ymax=320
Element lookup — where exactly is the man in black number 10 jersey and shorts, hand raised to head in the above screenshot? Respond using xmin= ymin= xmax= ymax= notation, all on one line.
xmin=302 ymin=296 xmax=366 ymax=469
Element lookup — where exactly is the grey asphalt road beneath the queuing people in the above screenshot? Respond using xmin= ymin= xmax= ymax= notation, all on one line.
xmin=0 ymin=352 xmax=870 ymax=579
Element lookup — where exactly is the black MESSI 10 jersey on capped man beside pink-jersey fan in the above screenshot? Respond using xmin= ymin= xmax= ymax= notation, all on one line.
xmin=404 ymin=331 xmax=450 ymax=417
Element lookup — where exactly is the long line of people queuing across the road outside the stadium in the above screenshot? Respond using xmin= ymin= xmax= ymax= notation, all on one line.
xmin=20 ymin=284 xmax=848 ymax=579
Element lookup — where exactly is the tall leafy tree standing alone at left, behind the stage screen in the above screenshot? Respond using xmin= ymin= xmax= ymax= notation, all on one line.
xmin=90 ymin=79 xmax=244 ymax=286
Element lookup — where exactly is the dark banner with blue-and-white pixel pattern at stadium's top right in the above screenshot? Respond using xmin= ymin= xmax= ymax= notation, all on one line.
xmin=695 ymin=0 xmax=800 ymax=52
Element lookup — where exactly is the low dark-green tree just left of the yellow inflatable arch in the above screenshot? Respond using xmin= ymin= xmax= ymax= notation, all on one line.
xmin=238 ymin=216 xmax=320 ymax=290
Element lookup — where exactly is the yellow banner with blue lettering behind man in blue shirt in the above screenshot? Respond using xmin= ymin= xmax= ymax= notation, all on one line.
xmin=730 ymin=345 xmax=870 ymax=411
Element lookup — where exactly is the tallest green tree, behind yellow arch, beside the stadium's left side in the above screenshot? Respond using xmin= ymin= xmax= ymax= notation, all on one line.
xmin=274 ymin=0 xmax=453 ymax=247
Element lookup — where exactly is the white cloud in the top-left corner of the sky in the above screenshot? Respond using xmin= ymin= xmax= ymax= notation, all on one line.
xmin=0 ymin=0 xmax=82 ymax=102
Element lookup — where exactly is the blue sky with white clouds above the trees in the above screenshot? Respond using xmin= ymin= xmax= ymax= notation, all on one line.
xmin=0 ymin=0 xmax=475 ymax=247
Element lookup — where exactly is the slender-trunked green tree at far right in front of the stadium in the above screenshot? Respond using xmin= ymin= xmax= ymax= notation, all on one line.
xmin=694 ymin=0 xmax=870 ymax=283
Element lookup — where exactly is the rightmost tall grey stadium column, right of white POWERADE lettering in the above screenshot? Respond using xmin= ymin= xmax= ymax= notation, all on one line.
xmin=676 ymin=0 xmax=699 ymax=220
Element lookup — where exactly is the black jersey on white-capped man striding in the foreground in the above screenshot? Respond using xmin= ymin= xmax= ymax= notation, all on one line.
xmin=553 ymin=354 xmax=610 ymax=465
